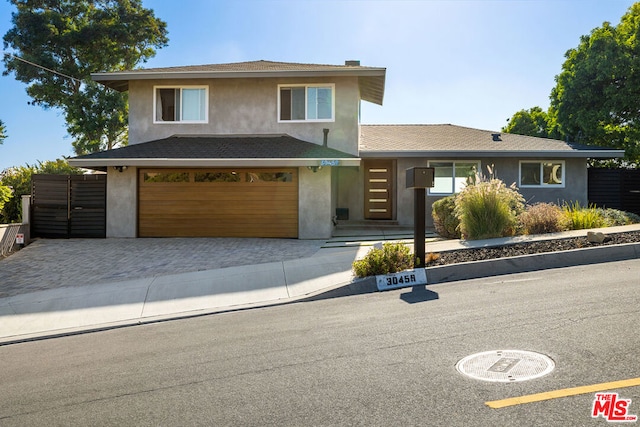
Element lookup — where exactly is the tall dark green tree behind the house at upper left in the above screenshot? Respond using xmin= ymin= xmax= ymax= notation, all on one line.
xmin=3 ymin=0 xmax=168 ymax=154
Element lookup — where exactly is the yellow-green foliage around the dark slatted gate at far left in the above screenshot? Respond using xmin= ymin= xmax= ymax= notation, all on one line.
xmin=0 ymin=159 xmax=82 ymax=223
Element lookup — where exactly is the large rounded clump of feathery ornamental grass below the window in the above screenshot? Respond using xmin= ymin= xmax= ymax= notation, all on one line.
xmin=454 ymin=178 xmax=524 ymax=240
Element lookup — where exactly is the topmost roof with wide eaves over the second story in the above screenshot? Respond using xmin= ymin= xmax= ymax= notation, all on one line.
xmin=91 ymin=60 xmax=386 ymax=105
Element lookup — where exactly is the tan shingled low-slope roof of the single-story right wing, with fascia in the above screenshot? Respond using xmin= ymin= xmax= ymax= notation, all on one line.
xmin=360 ymin=124 xmax=624 ymax=159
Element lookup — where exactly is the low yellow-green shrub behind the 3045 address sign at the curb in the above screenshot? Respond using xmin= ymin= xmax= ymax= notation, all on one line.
xmin=352 ymin=242 xmax=413 ymax=277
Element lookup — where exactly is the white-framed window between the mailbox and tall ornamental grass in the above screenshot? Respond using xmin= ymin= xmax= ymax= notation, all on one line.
xmin=428 ymin=160 xmax=480 ymax=195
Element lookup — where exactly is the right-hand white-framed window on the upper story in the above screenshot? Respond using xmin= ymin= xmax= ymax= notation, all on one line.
xmin=278 ymin=84 xmax=335 ymax=122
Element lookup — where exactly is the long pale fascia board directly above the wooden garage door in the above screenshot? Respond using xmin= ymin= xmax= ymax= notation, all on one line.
xmin=68 ymin=158 xmax=360 ymax=168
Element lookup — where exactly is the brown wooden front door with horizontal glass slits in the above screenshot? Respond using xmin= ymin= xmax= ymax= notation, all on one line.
xmin=364 ymin=160 xmax=395 ymax=219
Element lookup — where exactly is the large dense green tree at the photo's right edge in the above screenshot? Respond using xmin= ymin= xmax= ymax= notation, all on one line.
xmin=551 ymin=3 xmax=640 ymax=165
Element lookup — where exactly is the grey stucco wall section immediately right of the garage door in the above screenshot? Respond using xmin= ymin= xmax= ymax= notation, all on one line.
xmin=298 ymin=167 xmax=333 ymax=239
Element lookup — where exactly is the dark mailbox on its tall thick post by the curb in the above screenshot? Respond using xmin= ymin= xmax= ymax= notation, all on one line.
xmin=407 ymin=167 xmax=434 ymax=268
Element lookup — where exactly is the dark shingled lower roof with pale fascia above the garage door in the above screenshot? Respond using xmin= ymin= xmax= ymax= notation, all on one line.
xmin=69 ymin=135 xmax=360 ymax=169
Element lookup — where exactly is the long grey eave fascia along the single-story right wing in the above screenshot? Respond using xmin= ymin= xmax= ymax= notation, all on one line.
xmin=359 ymin=150 xmax=624 ymax=159
